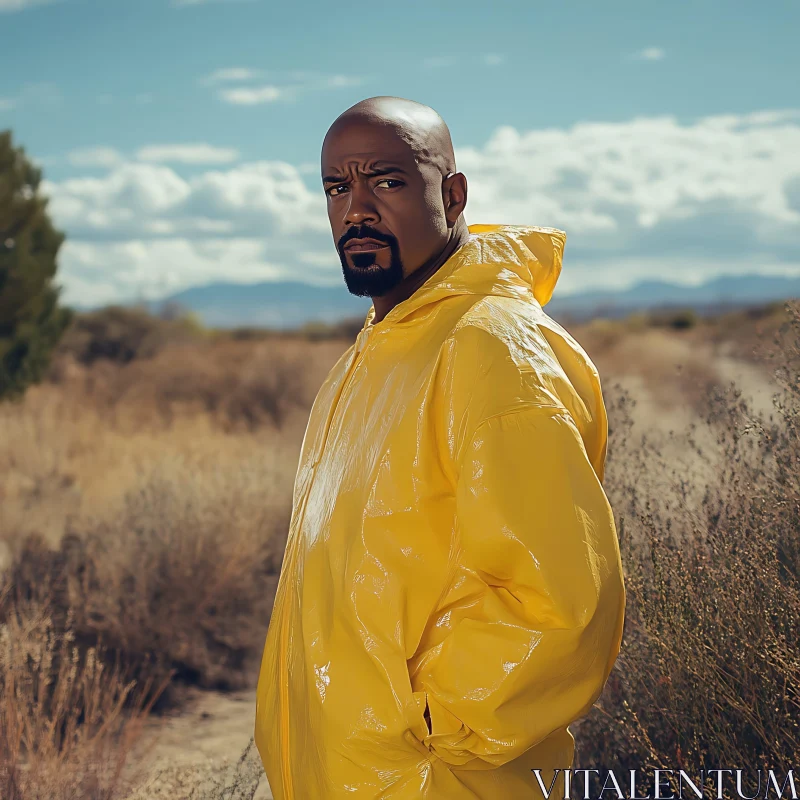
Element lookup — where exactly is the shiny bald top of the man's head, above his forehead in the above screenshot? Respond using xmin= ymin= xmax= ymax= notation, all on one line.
xmin=323 ymin=97 xmax=456 ymax=175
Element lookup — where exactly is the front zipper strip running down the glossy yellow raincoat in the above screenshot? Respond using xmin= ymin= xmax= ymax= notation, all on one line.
xmin=278 ymin=325 xmax=372 ymax=800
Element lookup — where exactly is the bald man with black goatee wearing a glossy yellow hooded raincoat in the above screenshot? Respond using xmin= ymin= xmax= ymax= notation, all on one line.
xmin=255 ymin=97 xmax=625 ymax=800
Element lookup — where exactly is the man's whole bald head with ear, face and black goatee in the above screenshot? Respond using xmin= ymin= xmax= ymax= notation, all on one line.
xmin=322 ymin=97 xmax=467 ymax=308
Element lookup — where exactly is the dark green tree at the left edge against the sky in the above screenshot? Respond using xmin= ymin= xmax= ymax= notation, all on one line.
xmin=0 ymin=130 xmax=72 ymax=400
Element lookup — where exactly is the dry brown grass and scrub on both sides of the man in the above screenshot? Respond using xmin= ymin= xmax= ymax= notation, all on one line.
xmin=0 ymin=307 xmax=800 ymax=800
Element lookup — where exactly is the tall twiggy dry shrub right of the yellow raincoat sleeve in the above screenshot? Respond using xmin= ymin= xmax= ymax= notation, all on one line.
xmin=575 ymin=303 xmax=800 ymax=788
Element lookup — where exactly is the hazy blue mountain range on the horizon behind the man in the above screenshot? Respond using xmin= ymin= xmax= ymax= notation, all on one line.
xmin=72 ymin=275 xmax=800 ymax=329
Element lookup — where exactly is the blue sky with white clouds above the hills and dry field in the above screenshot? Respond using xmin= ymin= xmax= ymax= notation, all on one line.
xmin=0 ymin=0 xmax=800 ymax=305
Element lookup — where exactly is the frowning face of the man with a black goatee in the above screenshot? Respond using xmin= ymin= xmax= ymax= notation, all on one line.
xmin=322 ymin=119 xmax=448 ymax=297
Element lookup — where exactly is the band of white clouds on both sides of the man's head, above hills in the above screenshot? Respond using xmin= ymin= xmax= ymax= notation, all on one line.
xmin=43 ymin=110 xmax=800 ymax=302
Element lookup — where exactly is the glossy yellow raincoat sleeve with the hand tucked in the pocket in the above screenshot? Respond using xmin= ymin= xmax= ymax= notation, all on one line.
xmin=412 ymin=406 xmax=625 ymax=769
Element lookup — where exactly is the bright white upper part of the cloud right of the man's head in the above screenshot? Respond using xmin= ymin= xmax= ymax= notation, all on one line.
xmin=457 ymin=112 xmax=800 ymax=236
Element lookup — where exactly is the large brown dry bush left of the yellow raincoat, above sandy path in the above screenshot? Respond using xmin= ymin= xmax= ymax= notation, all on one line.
xmin=2 ymin=468 xmax=288 ymax=703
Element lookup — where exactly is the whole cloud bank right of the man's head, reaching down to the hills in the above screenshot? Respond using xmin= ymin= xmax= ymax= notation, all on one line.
xmin=456 ymin=111 xmax=800 ymax=291
